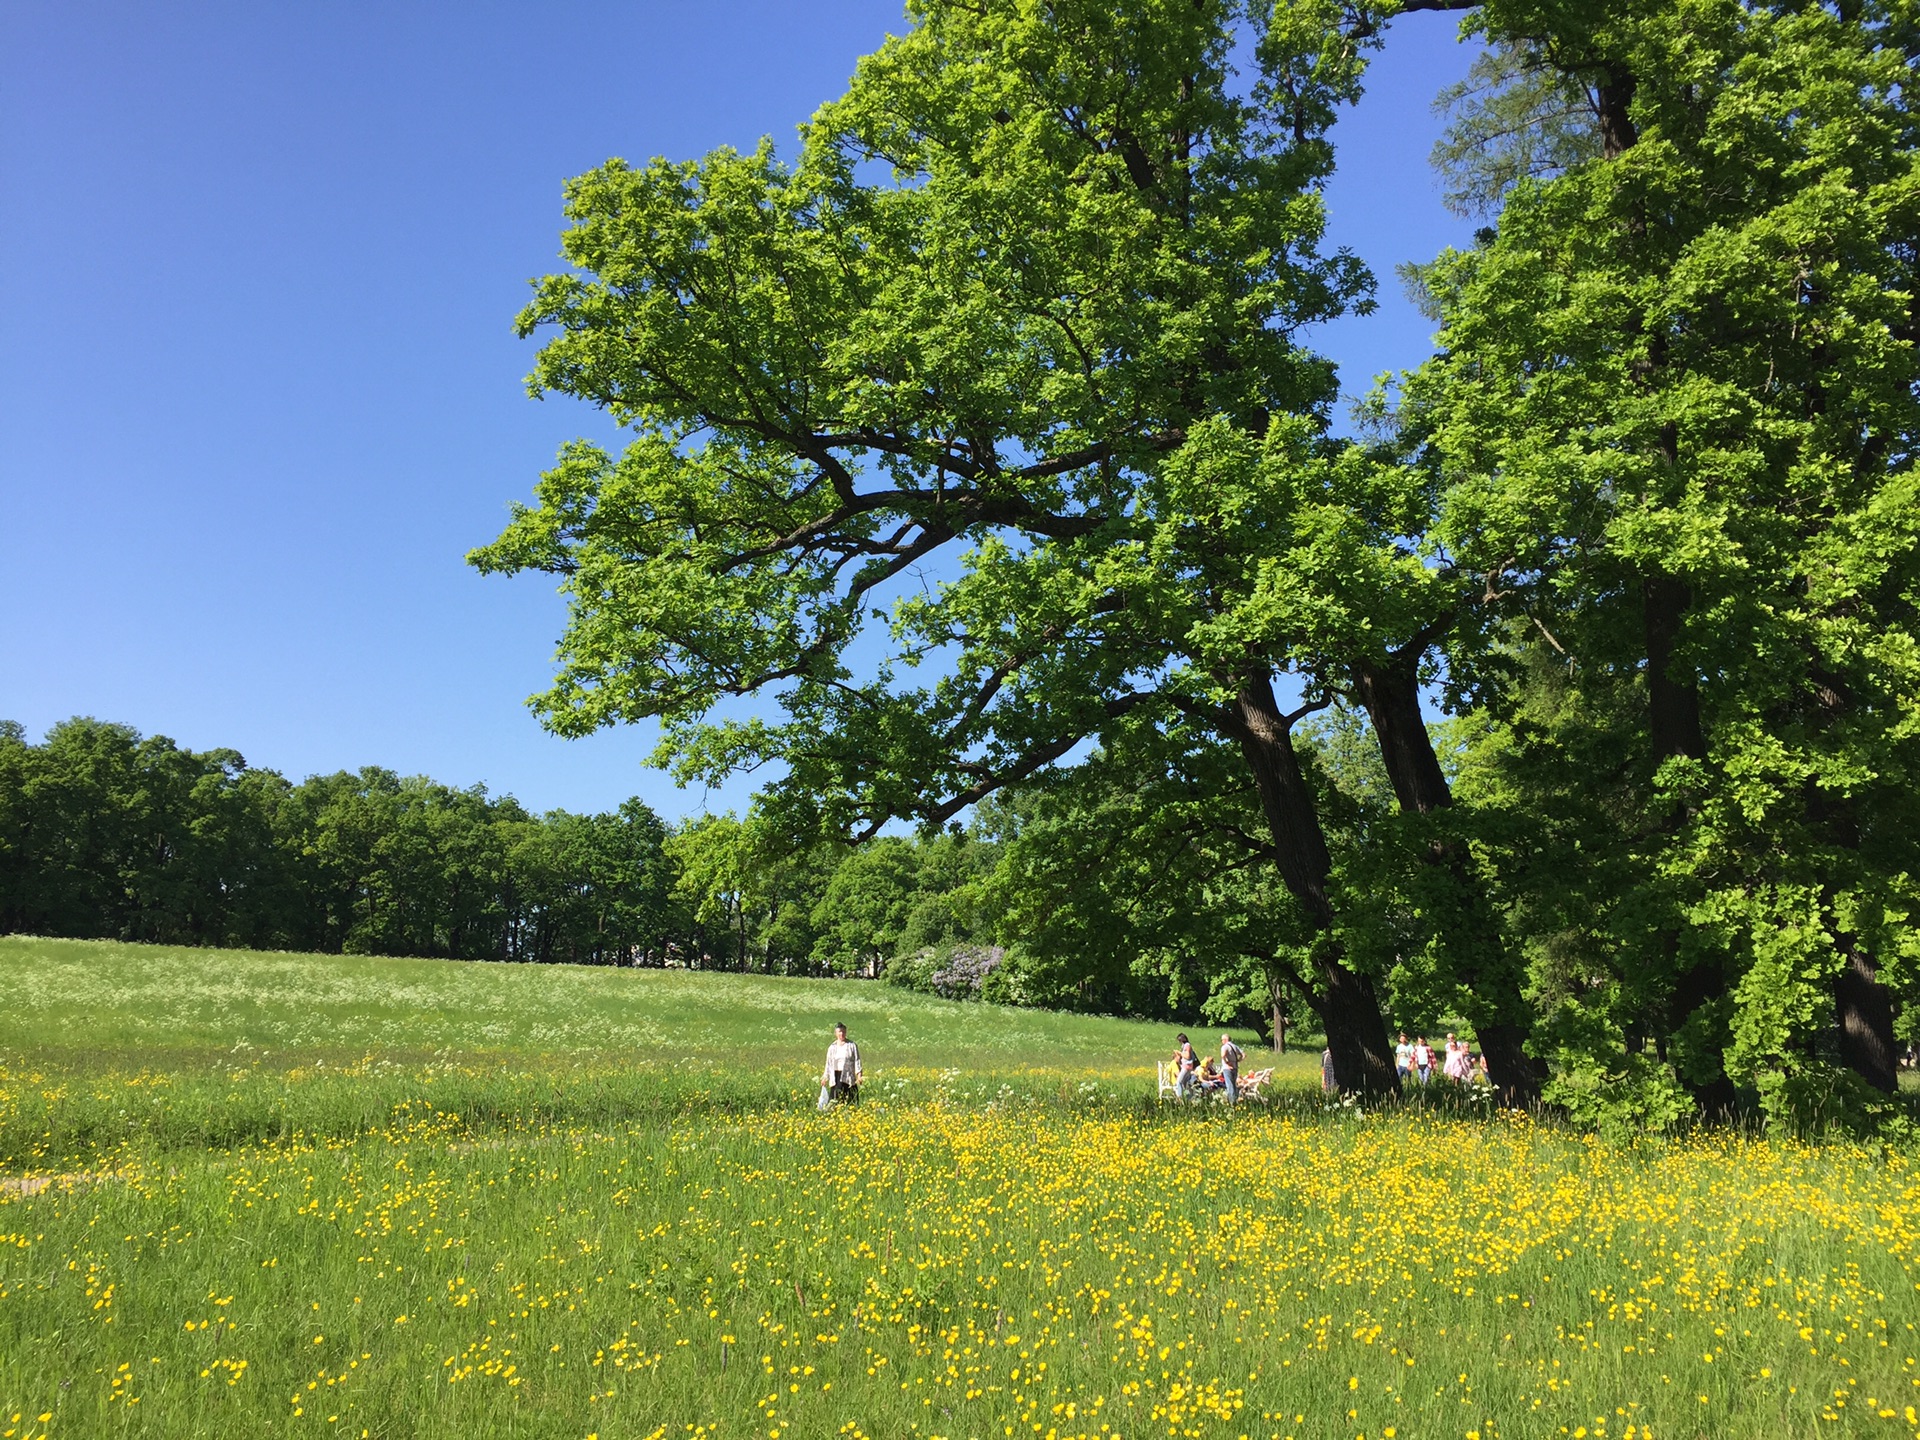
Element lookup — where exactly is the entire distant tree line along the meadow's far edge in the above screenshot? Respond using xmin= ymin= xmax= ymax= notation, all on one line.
xmin=0 ymin=718 xmax=1297 ymax=1027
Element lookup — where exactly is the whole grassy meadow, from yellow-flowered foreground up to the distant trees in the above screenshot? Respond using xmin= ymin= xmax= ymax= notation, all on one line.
xmin=0 ymin=939 xmax=1920 ymax=1440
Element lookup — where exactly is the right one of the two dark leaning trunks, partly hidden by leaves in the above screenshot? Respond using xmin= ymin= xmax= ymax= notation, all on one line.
xmin=1352 ymin=655 xmax=1540 ymax=1106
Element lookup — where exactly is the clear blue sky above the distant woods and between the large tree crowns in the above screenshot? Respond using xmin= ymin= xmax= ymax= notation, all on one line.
xmin=0 ymin=0 xmax=1471 ymax=816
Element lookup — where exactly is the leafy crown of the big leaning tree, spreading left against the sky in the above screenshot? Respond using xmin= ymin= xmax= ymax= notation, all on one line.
xmin=470 ymin=0 xmax=1382 ymax=835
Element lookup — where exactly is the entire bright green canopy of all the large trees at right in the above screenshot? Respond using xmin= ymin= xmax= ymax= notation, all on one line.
xmin=472 ymin=0 xmax=1920 ymax=1114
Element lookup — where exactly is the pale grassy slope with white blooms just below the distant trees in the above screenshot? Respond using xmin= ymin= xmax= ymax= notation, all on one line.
xmin=0 ymin=935 xmax=1213 ymax=1069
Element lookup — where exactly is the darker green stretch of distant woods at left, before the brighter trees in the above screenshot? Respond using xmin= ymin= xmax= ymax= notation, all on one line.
xmin=0 ymin=720 xmax=697 ymax=964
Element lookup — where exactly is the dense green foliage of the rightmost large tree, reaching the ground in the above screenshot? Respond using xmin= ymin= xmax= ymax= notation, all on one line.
xmin=1407 ymin=0 xmax=1920 ymax=1117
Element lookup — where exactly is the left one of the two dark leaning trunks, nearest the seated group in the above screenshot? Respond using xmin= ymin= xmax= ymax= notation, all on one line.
xmin=1229 ymin=674 xmax=1400 ymax=1096
